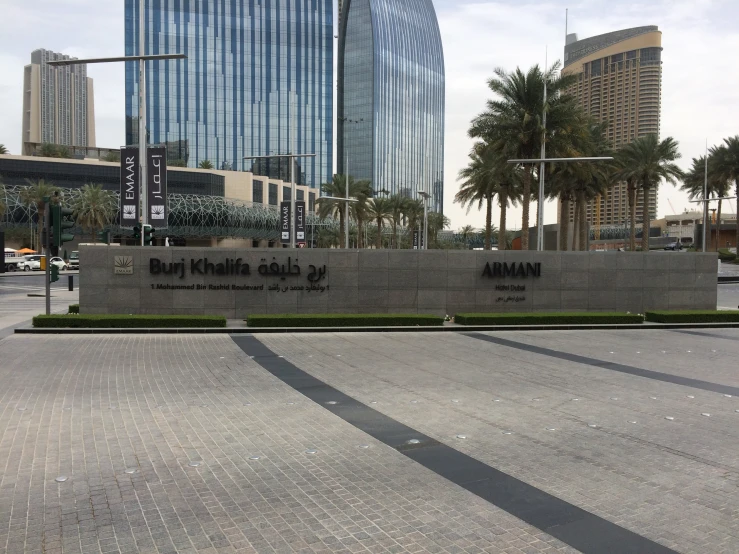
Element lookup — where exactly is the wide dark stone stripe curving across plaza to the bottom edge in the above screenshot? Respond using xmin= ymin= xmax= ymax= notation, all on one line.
xmin=231 ymin=335 xmax=675 ymax=554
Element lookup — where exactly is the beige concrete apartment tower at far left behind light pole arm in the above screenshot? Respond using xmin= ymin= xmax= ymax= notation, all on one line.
xmin=23 ymin=49 xmax=95 ymax=154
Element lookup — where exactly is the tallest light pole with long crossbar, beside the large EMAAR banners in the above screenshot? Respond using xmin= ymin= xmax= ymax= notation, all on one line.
xmin=47 ymin=5 xmax=187 ymax=246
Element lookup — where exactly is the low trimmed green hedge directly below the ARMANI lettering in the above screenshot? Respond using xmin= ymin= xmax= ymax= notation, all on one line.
xmin=454 ymin=312 xmax=644 ymax=325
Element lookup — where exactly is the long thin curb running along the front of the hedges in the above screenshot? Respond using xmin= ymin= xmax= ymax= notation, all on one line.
xmin=15 ymin=322 xmax=739 ymax=335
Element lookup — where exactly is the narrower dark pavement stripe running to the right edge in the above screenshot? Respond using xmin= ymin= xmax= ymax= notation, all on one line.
xmin=465 ymin=333 xmax=739 ymax=396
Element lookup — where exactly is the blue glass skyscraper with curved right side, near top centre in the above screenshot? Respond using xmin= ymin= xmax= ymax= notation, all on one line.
xmin=338 ymin=0 xmax=445 ymax=212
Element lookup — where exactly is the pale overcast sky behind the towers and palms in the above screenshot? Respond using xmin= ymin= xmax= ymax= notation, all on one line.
xmin=0 ymin=0 xmax=739 ymax=229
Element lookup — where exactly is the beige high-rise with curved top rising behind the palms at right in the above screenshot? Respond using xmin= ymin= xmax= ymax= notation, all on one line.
xmin=558 ymin=26 xmax=662 ymax=226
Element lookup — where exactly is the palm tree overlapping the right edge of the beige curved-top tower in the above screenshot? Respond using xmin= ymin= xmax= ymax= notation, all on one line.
xmin=621 ymin=134 xmax=683 ymax=252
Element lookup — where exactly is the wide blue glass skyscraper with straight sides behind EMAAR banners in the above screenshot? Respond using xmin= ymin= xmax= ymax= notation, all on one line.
xmin=125 ymin=0 xmax=334 ymax=187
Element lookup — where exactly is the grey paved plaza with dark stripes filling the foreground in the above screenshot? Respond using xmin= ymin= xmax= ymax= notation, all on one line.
xmin=0 ymin=330 xmax=739 ymax=554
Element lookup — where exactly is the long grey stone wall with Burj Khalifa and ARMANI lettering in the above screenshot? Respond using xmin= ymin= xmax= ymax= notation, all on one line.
xmin=80 ymin=246 xmax=718 ymax=319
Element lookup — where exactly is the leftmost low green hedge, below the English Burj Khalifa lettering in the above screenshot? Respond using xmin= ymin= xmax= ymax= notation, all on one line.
xmin=33 ymin=314 xmax=226 ymax=329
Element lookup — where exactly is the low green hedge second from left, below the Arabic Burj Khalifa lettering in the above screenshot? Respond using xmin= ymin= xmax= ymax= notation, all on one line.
xmin=246 ymin=314 xmax=444 ymax=327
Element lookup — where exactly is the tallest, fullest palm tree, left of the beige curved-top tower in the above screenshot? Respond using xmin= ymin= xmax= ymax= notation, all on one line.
xmin=469 ymin=62 xmax=580 ymax=250
